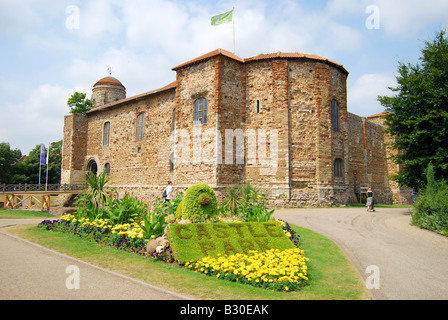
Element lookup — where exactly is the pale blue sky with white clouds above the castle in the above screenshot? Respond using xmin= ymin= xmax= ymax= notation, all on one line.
xmin=0 ymin=0 xmax=448 ymax=154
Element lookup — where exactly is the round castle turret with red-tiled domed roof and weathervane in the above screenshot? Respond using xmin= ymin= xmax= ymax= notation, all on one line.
xmin=91 ymin=76 xmax=126 ymax=108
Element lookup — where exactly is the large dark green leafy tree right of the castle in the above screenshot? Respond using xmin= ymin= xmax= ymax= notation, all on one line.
xmin=378 ymin=31 xmax=448 ymax=188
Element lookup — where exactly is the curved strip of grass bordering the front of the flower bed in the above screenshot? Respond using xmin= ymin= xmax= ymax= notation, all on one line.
xmin=0 ymin=210 xmax=370 ymax=300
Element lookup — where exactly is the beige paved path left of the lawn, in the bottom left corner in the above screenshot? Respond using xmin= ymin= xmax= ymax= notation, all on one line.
xmin=0 ymin=219 xmax=188 ymax=300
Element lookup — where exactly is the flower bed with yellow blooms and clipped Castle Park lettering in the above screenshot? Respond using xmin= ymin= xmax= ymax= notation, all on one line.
xmin=38 ymin=178 xmax=309 ymax=291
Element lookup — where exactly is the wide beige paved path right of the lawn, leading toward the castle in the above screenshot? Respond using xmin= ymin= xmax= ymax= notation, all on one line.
xmin=274 ymin=208 xmax=448 ymax=300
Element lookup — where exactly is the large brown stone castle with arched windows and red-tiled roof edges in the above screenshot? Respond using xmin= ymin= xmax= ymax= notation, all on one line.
xmin=61 ymin=49 xmax=410 ymax=207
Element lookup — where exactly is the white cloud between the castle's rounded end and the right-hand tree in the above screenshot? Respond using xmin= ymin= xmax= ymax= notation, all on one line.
xmin=347 ymin=73 xmax=396 ymax=116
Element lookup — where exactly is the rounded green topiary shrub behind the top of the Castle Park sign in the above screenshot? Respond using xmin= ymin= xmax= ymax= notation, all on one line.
xmin=181 ymin=183 xmax=218 ymax=221
